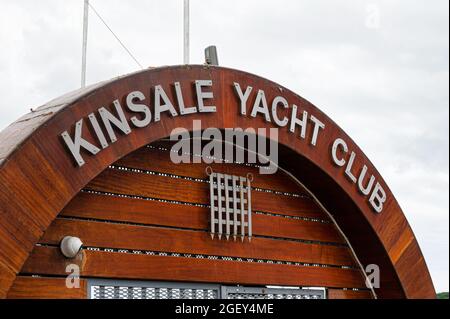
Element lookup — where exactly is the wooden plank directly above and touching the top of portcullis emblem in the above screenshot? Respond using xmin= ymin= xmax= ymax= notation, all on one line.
xmin=114 ymin=143 xmax=306 ymax=194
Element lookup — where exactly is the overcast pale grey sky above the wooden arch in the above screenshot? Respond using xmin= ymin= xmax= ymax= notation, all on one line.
xmin=0 ymin=0 xmax=449 ymax=291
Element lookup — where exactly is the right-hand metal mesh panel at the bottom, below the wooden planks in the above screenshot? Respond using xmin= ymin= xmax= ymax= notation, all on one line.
xmin=221 ymin=286 xmax=325 ymax=299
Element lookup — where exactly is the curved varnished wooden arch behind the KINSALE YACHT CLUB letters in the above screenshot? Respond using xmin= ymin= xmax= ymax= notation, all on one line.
xmin=0 ymin=66 xmax=435 ymax=298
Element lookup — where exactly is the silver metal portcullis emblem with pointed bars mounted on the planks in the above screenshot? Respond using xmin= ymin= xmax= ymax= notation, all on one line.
xmin=209 ymin=172 xmax=252 ymax=241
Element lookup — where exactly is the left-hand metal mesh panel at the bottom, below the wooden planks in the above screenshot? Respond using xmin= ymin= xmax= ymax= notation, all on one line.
xmin=89 ymin=280 xmax=219 ymax=299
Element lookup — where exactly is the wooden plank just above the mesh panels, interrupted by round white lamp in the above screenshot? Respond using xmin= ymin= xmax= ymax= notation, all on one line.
xmin=22 ymin=247 xmax=365 ymax=288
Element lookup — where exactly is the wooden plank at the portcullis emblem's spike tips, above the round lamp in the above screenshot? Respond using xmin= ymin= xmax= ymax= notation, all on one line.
xmin=40 ymin=219 xmax=355 ymax=266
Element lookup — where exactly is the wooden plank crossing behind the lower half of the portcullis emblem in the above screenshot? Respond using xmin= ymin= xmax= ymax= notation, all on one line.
xmin=61 ymin=193 xmax=345 ymax=244
